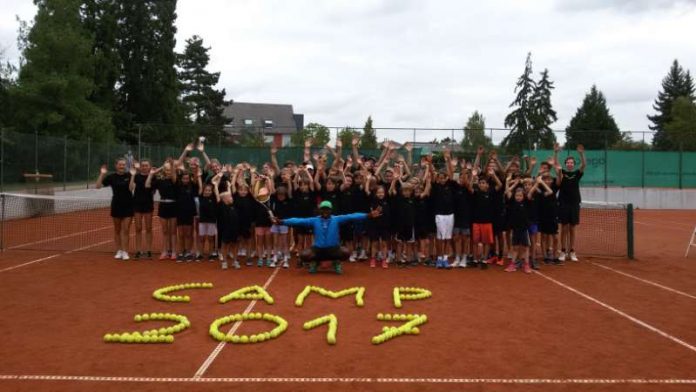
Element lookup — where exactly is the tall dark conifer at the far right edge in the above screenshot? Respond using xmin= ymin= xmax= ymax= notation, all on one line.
xmin=648 ymin=60 xmax=696 ymax=150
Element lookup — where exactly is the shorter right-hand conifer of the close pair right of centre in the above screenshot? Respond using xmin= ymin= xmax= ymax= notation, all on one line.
xmin=529 ymin=69 xmax=558 ymax=149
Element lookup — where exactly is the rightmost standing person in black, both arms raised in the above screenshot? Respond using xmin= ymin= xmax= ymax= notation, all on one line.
xmin=554 ymin=143 xmax=587 ymax=261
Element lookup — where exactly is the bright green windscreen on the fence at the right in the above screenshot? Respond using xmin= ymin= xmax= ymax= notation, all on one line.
xmin=526 ymin=150 xmax=696 ymax=188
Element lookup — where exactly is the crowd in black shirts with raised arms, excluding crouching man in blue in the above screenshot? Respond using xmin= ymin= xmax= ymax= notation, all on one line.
xmin=97 ymin=139 xmax=585 ymax=272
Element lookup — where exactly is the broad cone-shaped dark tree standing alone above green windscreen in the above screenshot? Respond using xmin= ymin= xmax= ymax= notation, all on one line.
xmin=566 ymin=85 xmax=622 ymax=150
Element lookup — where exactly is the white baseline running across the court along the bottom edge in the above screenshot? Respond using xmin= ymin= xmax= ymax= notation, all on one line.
xmin=0 ymin=374 xmax=696 ymax=385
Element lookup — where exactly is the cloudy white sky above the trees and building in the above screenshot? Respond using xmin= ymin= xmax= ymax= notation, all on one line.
xmin=0 ymin=0 xmax=696 ymax=139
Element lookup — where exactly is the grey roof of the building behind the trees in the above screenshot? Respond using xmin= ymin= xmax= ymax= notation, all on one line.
xmin=223 ymin=102 xmax=303 ymax=134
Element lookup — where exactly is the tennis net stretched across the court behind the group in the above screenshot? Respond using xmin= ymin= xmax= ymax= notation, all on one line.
xmin=0 ymin=193 xmax=633 ymax=258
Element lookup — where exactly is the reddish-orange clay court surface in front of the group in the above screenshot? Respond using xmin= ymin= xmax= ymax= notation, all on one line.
xmin=0 ymin=210 xmax=696 ymax=391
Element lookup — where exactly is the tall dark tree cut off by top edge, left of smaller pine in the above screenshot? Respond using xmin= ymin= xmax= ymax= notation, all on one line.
xmin=116 ymin=0 xmax=188 ymax=143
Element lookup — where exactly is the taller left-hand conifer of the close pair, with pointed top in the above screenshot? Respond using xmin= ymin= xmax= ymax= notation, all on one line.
xmin=501 ymin=53 xmax=536 ymax=154
